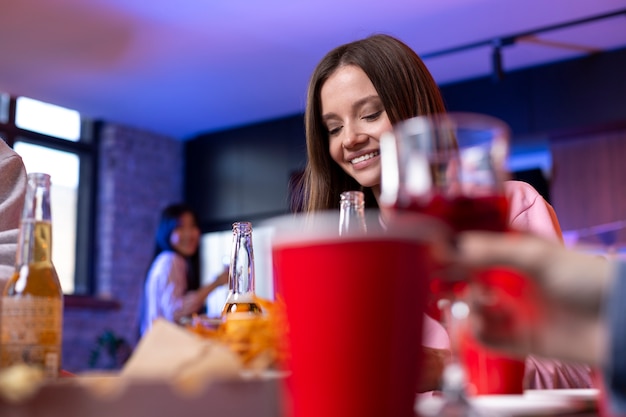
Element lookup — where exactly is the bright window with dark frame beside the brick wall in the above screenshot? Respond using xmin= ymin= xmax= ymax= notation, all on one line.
xmin=0 ymin=94 xmax=96 ymax=295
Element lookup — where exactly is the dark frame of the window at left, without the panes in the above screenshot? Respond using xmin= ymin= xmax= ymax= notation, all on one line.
xmin=0 ymin=94 xmax=101 ymax=296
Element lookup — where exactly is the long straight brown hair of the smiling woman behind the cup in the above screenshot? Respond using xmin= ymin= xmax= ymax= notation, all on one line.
xmin=292 ymin=35 xmax=445 ymax=211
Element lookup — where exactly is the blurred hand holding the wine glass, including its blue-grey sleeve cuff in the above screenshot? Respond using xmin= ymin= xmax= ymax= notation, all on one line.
xmin=450 ymin=232 xmax=626 ymax=415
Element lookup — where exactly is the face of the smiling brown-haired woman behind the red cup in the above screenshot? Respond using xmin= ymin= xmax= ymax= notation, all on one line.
xmin=320 ymin=65 xmax=392 ymax=196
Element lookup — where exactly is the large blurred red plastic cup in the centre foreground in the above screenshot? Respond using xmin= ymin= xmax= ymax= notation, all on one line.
xmin=272 ymin=211 xmax=437 ymax=417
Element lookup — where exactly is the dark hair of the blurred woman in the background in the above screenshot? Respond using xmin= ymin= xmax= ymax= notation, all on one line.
xmin=152 ymin=203 xmax=200 ymax=291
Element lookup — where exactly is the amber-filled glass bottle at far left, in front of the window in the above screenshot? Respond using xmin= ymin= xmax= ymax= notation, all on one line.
xmin=0 ymin=173 xmax=63 ymax=378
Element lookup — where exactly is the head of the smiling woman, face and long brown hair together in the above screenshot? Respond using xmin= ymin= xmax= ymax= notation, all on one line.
xmin=301 ymin=35 xmax=445 ymax=211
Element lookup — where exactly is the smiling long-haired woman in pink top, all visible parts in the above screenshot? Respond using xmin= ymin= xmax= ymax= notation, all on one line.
xmin=295 ymin=35 xmax=591 ymax=391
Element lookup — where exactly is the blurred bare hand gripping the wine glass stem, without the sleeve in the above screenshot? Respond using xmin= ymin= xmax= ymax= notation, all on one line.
xmin=453 ymin=232 xmax=613 ymax=365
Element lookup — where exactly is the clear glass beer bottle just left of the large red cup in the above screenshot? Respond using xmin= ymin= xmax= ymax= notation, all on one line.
xmin=222 ymin=222 xmax=262 ymax=317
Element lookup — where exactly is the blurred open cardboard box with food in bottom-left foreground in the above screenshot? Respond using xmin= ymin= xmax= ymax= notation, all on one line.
xmin=0 ymin=319 xmax=282 ymax=417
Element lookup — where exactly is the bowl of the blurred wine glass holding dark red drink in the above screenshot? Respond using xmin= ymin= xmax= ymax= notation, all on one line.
xmin=380 ymin=113 xmax=509 ymax=231
